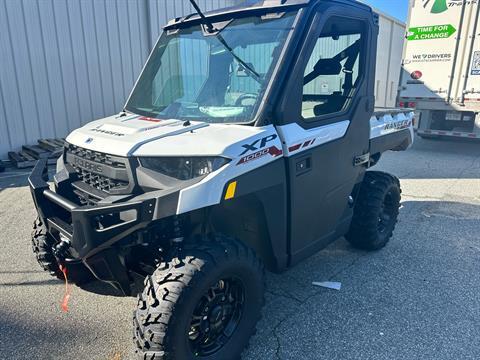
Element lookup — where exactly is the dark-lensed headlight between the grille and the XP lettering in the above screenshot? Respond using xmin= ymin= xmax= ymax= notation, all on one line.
xmin=139 ymin=157 xmax=230 ymax=180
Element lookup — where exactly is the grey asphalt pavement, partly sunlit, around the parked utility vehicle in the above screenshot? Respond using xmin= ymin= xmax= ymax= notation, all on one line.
xmin=0 ymin=136 xmax=480 ymax=360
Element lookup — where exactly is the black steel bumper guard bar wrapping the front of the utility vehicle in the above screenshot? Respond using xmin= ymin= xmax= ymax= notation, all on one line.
xmin=28 ymin=160 xmax=157 ymax=259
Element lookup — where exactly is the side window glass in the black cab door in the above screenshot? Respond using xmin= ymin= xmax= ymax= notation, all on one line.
xmin=302 ymin=17 xmax=365 ymax=121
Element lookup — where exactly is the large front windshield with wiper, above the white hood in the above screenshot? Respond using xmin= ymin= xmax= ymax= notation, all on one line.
xmin=126 ymin=13 xmax=294 ymax=123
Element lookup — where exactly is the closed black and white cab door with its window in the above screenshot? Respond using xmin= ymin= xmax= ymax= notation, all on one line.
xmin=277 ymin=2 xmax=378 ymax=264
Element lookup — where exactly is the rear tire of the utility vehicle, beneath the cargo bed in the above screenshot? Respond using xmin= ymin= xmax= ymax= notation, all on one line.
xmin=345 ymin=171 xmax=402 ymax=250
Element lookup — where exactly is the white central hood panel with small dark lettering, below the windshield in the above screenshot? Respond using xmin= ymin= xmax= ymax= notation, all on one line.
xmin=66 ymin=115 xmax=209 ymax=156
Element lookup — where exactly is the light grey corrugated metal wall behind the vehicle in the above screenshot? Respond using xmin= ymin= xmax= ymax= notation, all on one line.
xmin=0 ymin=0 xmax=241 ymax=159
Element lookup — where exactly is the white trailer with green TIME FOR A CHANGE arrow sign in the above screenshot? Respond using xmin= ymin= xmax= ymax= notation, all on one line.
xmin=399 ymin=0 xmax=480 ymax=139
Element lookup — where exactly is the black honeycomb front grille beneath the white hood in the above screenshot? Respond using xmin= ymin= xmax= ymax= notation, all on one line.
xmin=66 ymin=144 xmax=130 ymax=200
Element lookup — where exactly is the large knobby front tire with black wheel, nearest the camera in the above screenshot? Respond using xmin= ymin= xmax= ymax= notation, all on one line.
xmin=133 ymin=235 xmax=265 ymax=360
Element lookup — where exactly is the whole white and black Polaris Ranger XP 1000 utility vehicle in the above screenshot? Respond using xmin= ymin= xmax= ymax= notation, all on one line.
xmin=29 ymin=0 xmax=413 ymax=360
